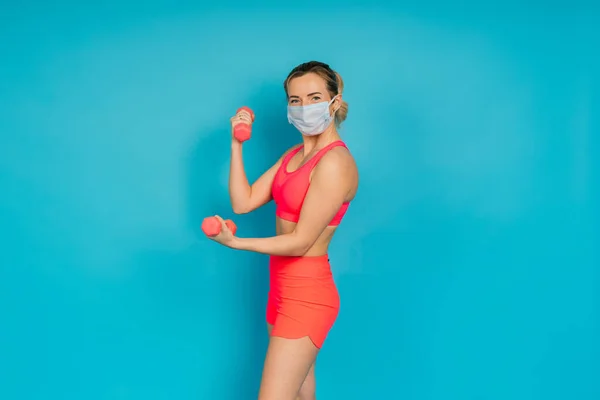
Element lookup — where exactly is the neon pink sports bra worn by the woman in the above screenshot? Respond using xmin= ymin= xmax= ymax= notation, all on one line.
xmin=271 ymin=140 xmax=350 ymax=226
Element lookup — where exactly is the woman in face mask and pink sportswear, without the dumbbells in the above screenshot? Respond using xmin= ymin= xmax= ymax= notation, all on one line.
xmin=207 ymin=61 xmax=358 ymax=400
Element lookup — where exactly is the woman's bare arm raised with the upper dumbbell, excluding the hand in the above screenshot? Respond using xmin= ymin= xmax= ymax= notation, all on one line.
xmin=229 ymin=139 xmax=282 ymax=214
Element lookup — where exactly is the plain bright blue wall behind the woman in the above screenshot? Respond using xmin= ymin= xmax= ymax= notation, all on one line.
xmin=0 ymin=1 xmax=600 ymax=400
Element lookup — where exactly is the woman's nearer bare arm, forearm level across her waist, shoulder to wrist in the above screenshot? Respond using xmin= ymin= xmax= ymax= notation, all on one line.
xmin=223 ymin=149 xmax=354 ymax=256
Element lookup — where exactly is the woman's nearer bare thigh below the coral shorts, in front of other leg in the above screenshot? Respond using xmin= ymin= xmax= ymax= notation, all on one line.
xmin=258 ymin=336 xmax=319 ymax=400
